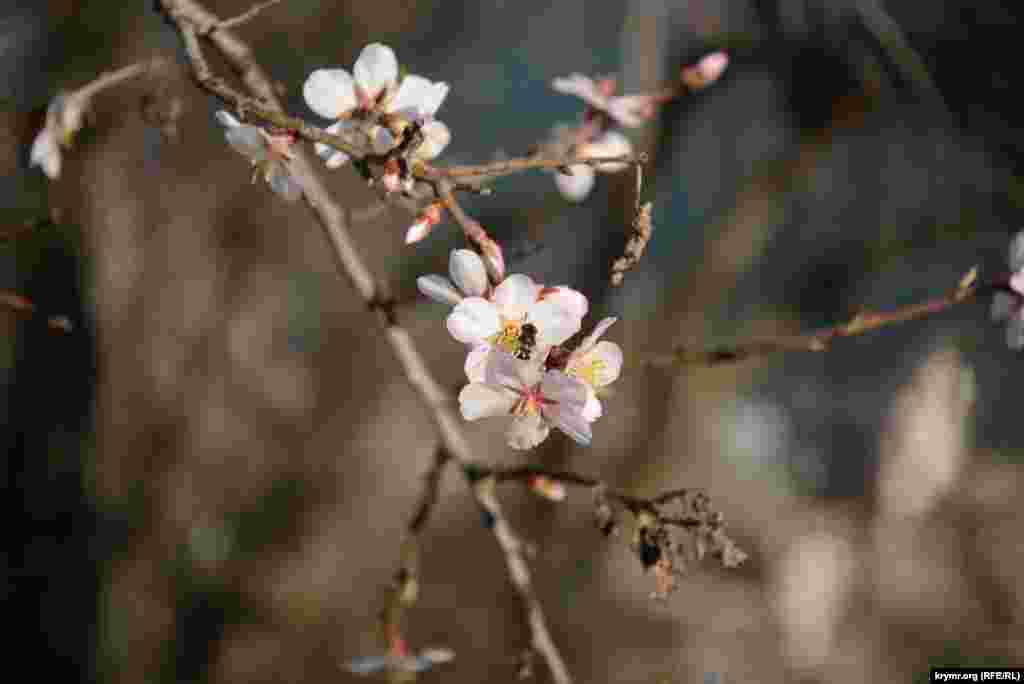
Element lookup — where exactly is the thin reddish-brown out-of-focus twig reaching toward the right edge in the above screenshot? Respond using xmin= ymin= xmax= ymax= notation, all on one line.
xmin=648 ymin=269 xmax=998 ymax=366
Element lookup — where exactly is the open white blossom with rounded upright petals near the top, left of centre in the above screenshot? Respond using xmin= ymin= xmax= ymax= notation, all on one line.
xmin=302 ymin=43 xmax=452 ymax=168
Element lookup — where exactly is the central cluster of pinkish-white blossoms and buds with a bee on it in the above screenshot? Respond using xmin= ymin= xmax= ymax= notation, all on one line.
xmin=417 ymin=250 xmax=623 ymax=448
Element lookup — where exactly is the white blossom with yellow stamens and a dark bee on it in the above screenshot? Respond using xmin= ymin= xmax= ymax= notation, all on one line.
xmin=446 ymin=273 xmax=587 ymax=362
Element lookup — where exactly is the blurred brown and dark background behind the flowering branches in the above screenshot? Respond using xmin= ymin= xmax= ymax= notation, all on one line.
xmin=6 ymin=0 xmax=1024 ymax=684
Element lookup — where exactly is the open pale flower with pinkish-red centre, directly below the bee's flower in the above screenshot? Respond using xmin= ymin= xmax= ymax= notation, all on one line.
xmin=459 ymin=351 xmax=591 ymax=448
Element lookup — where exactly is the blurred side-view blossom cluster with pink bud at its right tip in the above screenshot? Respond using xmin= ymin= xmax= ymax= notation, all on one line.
xmin=551 ymin=52 xmax=729 ymax=202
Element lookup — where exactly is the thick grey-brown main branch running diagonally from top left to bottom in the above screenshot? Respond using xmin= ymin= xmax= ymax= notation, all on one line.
xmin=161 ymin=0 xmax=572 ymax=684
